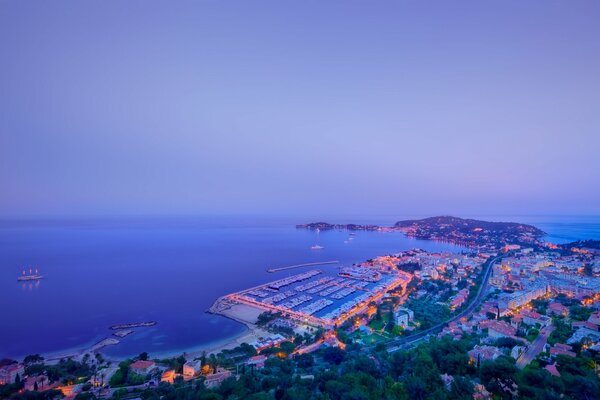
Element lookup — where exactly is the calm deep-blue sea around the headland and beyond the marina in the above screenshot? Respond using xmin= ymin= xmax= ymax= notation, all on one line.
xmin=0 ymin=217 xmax=600 ymax=358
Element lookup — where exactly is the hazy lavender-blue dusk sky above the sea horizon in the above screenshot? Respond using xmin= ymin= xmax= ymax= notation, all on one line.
xmin=0 ymin=0 xmax=600 ymax=217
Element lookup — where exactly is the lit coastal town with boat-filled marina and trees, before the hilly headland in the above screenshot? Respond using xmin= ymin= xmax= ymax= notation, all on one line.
xmin=0 ymin=219 xmax=600 ymax=399
